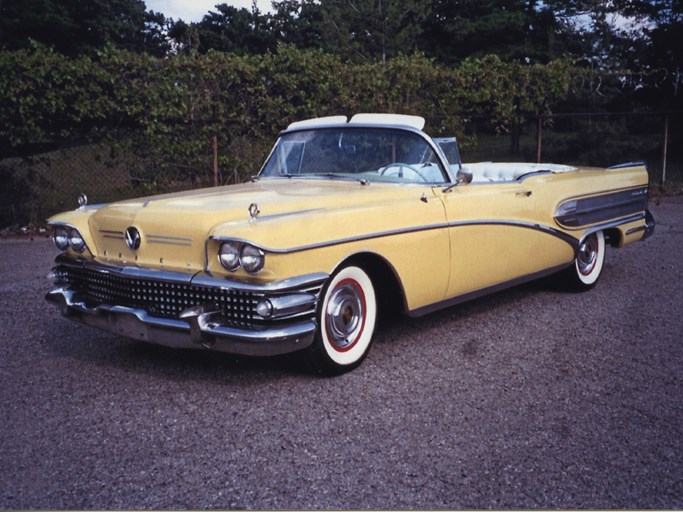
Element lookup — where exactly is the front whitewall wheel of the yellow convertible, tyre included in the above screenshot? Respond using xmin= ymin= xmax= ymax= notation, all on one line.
xmin=310 ymin=266 xmax=377 ymax=374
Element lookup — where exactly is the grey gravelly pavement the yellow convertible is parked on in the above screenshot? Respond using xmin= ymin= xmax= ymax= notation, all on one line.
xmin=0 ymin=198 xmax=683 ymax=509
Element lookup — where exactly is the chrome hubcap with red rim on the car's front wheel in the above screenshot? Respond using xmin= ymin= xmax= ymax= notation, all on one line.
xmin=325 ymin=280 xmax=365 ymax=350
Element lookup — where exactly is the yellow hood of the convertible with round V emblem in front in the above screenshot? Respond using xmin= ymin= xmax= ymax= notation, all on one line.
xmin=89 ymin=179 xmax=444 ymax=272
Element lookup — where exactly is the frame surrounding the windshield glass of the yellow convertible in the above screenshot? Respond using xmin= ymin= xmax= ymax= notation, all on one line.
xmin=255 ymin=123 xmax=455 ymax=187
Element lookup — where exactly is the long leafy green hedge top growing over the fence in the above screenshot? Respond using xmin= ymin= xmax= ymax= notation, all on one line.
xmin=0 ymin=45 xmax=578 ymax=180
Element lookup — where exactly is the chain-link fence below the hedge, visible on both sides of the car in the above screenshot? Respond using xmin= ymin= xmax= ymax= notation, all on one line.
xmin=0 ymin=112 xmax=683 ymax=229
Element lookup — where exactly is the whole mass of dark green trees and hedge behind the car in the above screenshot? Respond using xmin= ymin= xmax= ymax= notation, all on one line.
xmin=0 ymin=0 xmax=683 ymax=228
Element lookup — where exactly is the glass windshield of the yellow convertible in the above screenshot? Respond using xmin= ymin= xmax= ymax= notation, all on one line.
xmin=260 ymin=127 xmax=448 ymax=184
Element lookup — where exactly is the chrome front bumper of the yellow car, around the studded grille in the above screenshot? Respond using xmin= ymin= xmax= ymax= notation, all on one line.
xmin=45 ymin=257 xmax=326 ymax=356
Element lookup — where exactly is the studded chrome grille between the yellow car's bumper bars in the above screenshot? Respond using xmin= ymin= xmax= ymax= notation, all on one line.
xmin=58 ymin=266 xmax=260 ymax=327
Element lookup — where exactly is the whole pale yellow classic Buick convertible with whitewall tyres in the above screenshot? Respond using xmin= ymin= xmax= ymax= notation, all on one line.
xmin=46 ymin=114 xmax=655 ymax=374
